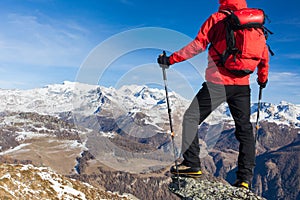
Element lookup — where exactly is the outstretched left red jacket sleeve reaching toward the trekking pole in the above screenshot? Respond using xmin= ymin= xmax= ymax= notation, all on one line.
xmin=169 ymin=16 xmax=215 ymax=65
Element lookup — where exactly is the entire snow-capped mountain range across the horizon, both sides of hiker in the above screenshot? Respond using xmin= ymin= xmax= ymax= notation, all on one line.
xmin=0 ymin=81 xmax=300 ymax=127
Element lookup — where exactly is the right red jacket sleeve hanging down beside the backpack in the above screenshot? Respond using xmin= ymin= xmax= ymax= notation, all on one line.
xmin=257 ymin=45 xmax=269 ymax=83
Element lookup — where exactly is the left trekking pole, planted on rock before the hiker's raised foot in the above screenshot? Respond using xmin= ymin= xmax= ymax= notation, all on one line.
xmin=162 ymin=51 xmax=180 ymax=189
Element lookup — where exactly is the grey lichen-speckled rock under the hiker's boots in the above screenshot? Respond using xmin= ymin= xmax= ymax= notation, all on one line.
xmin=169 ymin=175 xmax=264 ymax=200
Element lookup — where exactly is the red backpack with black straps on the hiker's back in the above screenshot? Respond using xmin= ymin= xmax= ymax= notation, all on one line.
xmin=211 ymin=8 xmax=274 ymax=76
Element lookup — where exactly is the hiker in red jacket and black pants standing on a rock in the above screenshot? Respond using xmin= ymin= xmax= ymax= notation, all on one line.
xmin=158 ymin=0 xmax=269 ymax=189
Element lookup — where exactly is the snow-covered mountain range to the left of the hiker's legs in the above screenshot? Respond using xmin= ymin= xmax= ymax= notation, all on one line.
xmin=0 ymin=82 xmax=187 ymax=120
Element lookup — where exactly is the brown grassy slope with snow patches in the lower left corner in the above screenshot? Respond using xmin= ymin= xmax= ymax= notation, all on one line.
xmin=0 ymin=164 xmax=133 ymax=200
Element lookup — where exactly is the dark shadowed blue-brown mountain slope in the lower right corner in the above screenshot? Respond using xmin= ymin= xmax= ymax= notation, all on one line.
xmin=254 ymin=135 xmax=300 ymax=200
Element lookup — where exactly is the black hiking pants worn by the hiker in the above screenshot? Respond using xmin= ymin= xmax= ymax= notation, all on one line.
xmin=182 ymin=82 xmax=255 ymax=181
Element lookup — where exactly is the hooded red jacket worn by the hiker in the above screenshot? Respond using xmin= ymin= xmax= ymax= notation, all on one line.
xmin=170 ymin=0 xmax=269 ymax=85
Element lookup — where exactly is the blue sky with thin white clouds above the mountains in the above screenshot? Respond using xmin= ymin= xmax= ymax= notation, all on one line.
xmin=0 ymin=0 xmax=300 ymax=104
